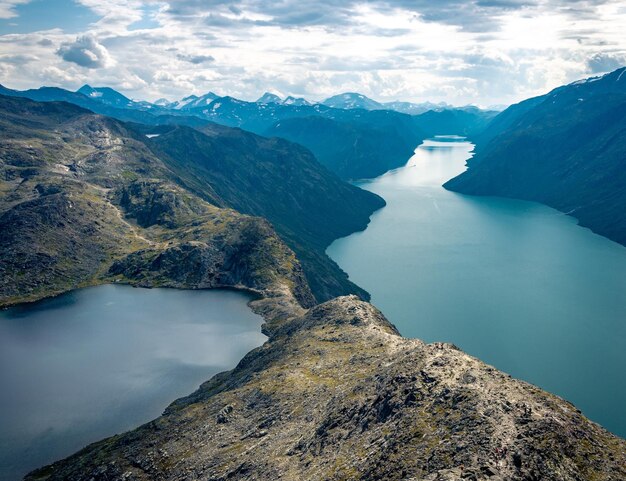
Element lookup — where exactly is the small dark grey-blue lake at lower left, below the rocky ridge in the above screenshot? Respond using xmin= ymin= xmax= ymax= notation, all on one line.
xmin=0 ymin=285 xmax=266 ymax=481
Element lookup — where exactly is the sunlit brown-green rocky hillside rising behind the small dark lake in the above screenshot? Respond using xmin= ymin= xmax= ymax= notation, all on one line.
xmin=0 ymin=96 xmax=314 ymax=307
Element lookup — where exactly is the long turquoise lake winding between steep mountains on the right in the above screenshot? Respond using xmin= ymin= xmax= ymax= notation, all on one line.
xmin=327 ymin=138 xmax=626 ymax=437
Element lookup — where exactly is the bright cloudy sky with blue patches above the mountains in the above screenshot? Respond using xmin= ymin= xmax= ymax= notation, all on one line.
xmin=0 ymin=0 xmax=626 ymax=106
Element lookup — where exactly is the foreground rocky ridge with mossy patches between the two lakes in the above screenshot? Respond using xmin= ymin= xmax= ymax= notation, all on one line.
xmin=28 ymin=297 xmax=626 ymax=481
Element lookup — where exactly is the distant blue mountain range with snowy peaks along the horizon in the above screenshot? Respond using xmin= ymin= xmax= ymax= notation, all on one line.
xmin=0 ymin=85 xmax=495 ymax=179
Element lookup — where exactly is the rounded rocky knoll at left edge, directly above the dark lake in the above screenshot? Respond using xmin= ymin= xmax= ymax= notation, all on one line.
xmin=0 ymin=180 xmax=141 ymax=307
